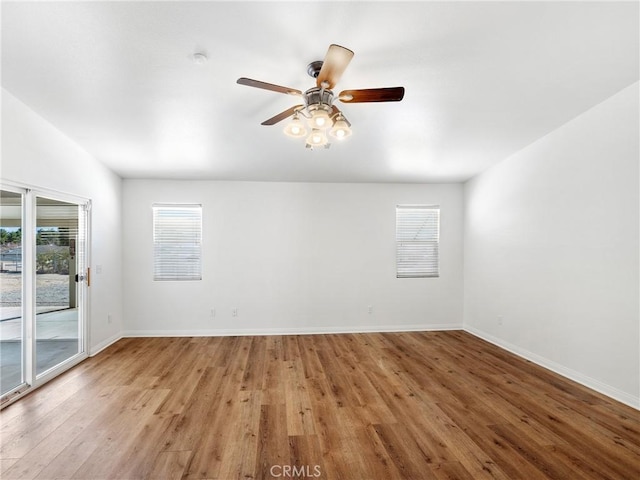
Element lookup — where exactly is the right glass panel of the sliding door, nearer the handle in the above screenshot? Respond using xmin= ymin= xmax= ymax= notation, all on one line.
xmin=34 ymin=197 xmax=84 ymax=378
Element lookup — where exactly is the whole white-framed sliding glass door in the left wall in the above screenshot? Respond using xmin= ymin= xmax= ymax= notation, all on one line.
xmin=0 ymin=187 xmax=88 ymax=402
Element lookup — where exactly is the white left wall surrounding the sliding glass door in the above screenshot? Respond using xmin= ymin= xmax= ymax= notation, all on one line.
xmin=0 ymin=89 xmax=122 ymax=354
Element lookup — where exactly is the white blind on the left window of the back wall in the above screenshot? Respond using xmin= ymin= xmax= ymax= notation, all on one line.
xmin=153 ymin=204 xmax=202 ymax=280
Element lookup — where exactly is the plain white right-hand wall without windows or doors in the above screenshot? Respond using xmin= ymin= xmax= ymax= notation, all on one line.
xmin=464 ymin=83 xmax=640 ymax=407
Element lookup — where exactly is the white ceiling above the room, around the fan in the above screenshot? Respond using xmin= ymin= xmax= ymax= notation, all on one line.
xmin=2 ymin=1 xmax=640 ymax=182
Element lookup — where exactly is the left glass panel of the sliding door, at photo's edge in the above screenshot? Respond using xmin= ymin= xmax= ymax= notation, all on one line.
xmin=0 ymin=190 xmax=25 ymax=395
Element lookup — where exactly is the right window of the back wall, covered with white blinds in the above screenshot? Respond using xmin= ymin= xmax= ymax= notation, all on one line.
xmin=396 ymin=205 xmax=440 ymax=278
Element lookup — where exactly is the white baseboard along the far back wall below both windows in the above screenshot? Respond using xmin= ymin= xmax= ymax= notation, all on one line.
xmin=122 ymin=324 xmax=462 ymax=337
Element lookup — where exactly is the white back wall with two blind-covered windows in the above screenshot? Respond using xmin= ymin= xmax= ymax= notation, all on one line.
xmin=123 ymin=180 xmax=462 ymax=335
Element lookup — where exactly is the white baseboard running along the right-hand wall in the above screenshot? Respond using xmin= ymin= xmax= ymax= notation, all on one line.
xmin=463 ymin=325 xmax=640 ymax=410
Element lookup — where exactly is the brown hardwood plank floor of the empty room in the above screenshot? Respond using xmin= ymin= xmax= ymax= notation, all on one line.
xmin=0 ymin=331 xmax=640 ymax=480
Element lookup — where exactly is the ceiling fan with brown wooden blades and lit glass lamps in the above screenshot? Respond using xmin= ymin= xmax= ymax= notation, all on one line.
xmin=237 ymin=44 xmax=404 ymax=149
